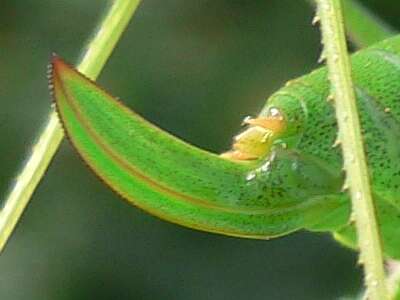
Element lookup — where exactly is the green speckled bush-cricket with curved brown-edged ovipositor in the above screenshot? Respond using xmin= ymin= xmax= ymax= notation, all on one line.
xmin=50 ymin=28 xmax=400 ymax=258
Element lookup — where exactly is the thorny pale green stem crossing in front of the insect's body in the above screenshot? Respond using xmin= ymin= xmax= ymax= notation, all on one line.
xmin=317 ymin=0 xmax=388 ymax=300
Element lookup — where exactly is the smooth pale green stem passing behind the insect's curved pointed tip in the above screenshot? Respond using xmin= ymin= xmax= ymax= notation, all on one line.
xmin=0 ymin=0 xmax=140 ymax=252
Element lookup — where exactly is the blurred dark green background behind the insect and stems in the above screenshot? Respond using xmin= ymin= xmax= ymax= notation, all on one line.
xmin=0 ymin=0 xmax=400 ymax=300
